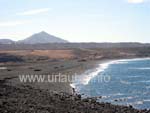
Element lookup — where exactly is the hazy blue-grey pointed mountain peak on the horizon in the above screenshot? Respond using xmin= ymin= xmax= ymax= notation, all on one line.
xmin=18 ymin=31 xmax=68 ymax=44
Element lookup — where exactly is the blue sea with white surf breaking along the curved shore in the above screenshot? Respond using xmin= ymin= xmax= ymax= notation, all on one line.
xmin=74 ymin=58 xmax=150 ymax=109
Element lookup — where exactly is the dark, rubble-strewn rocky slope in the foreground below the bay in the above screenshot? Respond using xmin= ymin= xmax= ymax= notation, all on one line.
xmin=0 ymin=80 xmax=150 ymax=113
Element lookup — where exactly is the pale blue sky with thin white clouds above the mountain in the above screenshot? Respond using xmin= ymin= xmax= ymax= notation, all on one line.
xmin=0 ymin=0 xmax=150 ymax=43
